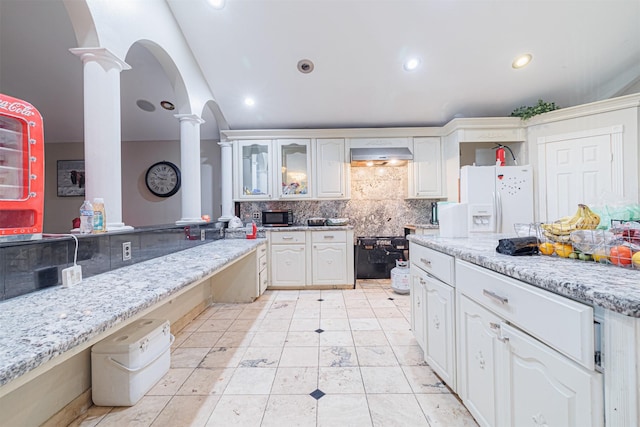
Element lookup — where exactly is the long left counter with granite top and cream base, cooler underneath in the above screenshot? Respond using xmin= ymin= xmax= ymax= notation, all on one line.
xmin=0 ymin=239 xmax=265 ymax=425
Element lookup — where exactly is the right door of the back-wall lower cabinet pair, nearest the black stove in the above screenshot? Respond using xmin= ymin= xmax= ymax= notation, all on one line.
xmin=311 ymin=243 xmax=347 ymax=285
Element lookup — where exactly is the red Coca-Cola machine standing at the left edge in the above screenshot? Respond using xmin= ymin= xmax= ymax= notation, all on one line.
xmin=0 ymin=93 xmax=44 ymax=242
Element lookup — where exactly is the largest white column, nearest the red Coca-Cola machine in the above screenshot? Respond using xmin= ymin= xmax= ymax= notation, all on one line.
xmin=69 ymin=48 xmax=132 ymax=231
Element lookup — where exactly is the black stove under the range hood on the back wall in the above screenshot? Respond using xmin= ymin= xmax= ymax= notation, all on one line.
xmin=355 ymin=236 xmax=409 ymax=279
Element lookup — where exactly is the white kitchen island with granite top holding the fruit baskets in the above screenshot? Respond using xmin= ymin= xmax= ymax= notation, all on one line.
xmin=409 ymin=234 xmax=640 ymax=426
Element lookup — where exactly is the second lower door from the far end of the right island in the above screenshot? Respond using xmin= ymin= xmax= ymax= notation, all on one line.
xmin=425 ymin=276 xmax=456 ymax=391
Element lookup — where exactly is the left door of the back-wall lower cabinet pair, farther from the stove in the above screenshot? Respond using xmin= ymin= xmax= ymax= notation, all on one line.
xmin=271 ymin=245 xmax=306 ymax=287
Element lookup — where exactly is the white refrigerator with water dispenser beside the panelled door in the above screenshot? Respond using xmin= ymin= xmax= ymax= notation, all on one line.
xmin=460 ymin=165 xmax=533 ymax=234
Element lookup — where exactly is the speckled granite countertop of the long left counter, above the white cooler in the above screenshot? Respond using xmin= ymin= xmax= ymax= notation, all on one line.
xmin=0 ymin=239 xmax=265 ymax=387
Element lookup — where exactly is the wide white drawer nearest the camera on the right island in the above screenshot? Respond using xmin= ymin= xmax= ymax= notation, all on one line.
xmin=456 ymin=261 xmax=594 ymax=369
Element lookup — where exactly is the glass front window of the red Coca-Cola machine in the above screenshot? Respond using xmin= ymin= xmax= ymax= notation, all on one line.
xmin=0 ymin=117 xmax=29 ymax=200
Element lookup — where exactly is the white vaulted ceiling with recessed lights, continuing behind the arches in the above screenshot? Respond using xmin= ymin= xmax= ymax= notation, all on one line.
xmin=0 ymin=0 xmax=640 ymax=142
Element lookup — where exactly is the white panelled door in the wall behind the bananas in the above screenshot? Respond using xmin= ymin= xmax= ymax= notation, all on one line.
xmin=541 ymin=135 xmax=613 ymax=221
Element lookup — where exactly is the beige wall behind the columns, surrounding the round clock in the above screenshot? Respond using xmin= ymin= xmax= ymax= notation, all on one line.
xmin=44 ymin=141 xmax=221 ymax=233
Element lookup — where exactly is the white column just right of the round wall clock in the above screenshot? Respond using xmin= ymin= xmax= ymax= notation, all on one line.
xmin=174 ymin=114 xmax=204 ymax=225
